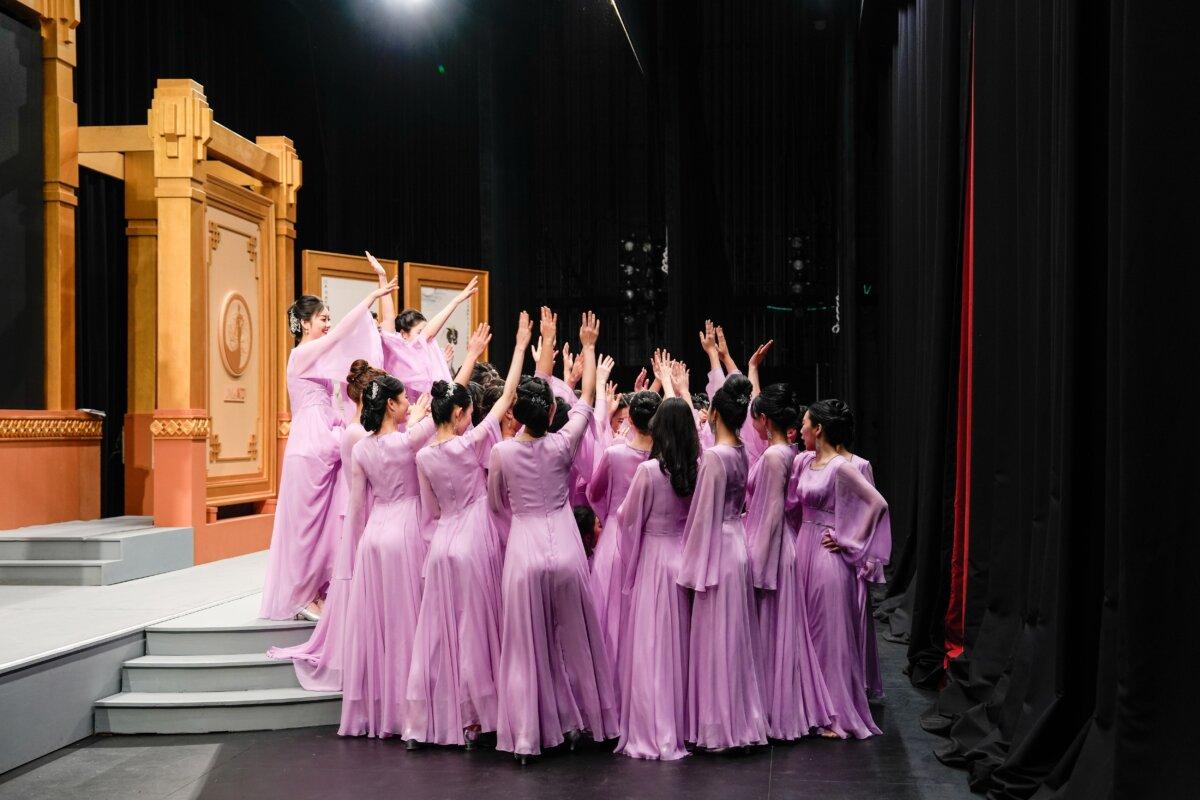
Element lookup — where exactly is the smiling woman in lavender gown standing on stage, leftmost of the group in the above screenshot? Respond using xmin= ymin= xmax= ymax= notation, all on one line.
xmin=258 ymin=281 xmax=396 ymax=619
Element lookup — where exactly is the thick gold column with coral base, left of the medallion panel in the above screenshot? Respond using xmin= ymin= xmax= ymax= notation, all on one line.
xmin=149 ymin=79 xmax=212 ymax=533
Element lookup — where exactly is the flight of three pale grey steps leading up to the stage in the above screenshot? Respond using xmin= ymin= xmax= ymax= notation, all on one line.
xmin=96 ymin=594 xmax=342 ymax=733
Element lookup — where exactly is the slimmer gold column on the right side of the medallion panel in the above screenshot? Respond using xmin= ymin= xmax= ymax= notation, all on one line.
xmin=254 ymin=136 xmax=304 ymax=501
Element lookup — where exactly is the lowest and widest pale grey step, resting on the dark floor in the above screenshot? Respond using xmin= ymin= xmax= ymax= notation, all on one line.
xmin=96 ymin=688 xmax=342 ymax=734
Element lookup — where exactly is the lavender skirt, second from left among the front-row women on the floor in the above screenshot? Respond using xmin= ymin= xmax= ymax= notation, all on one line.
xmin=404 ymin=495 xmax=502 ymax=745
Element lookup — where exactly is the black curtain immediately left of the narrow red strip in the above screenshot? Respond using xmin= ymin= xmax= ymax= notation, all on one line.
xmin=854 ymin=0 xmax=971 ymax=688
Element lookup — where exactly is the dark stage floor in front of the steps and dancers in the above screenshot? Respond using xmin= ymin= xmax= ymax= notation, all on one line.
xmin=0 ymin=639 xmax=974 ymax=800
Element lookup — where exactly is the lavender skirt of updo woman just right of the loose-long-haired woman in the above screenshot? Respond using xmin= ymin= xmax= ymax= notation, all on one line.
xmin=688 ymin=521 xmax=767 ymax=750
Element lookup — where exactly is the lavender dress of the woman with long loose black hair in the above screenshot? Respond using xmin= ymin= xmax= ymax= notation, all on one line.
xmin=616 ymin=459 xmax=691 ymax=760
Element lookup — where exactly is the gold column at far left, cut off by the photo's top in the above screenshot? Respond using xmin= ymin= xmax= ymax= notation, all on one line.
xmin=38 ymin=0 xmax=79 ymax=409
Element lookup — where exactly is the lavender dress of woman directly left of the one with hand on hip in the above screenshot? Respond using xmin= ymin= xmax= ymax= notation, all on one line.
xmin=746 ymin=445 xmax=830 ymax=740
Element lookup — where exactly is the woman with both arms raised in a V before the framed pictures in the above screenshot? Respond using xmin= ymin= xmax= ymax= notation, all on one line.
xmin=367 ymin=253 xmax=479 ymax=401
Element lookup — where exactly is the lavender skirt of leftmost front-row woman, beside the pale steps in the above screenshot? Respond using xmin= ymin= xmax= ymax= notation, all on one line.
xmin=337 ymin=495 xmax=428 ymax=738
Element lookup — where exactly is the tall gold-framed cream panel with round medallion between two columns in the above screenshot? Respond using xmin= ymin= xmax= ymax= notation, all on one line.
xmin=204 ymin=175 xmax=278 ymax=506
